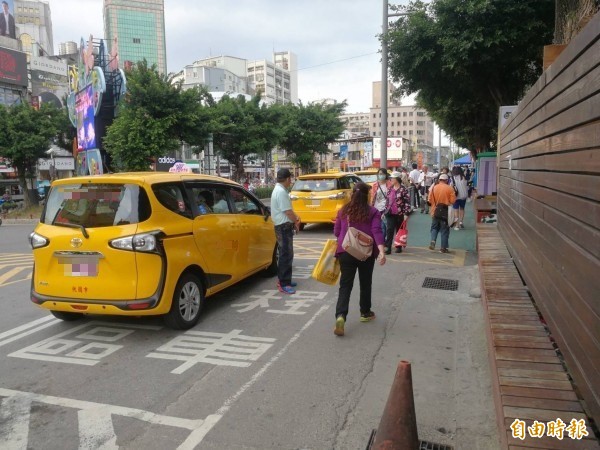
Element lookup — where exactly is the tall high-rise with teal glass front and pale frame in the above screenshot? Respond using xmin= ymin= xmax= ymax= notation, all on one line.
xmin=104 ymin=0 xmax=167 ymax=73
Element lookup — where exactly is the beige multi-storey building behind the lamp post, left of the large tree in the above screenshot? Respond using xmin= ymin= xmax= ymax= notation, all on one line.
xmin=370 ymin=81 xmax=433 ymax=147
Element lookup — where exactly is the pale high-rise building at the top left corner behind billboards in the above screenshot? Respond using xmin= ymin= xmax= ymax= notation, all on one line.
xmin=14 ymin=0 xmax=54 ymax=56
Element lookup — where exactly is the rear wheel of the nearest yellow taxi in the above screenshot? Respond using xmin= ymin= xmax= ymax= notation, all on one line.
xmin=165 ymin=273 xmax=204 ymax=330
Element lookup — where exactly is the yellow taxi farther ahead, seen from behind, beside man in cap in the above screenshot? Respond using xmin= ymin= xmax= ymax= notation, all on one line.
xmin=290 ymin=172 xmax=361 ymax=229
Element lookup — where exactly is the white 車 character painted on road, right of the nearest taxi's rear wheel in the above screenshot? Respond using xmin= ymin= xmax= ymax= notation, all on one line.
xmin=146 ymin=330 xmax=275 ymax=374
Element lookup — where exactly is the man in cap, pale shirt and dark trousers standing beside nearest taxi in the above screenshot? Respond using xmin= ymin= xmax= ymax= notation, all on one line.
xmin=271 ymin=169 xmax=300 ymax=294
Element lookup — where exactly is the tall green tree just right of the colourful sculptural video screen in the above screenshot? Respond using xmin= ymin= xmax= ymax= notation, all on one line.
xmin=103 ymin=60 xmax=210 ymax=171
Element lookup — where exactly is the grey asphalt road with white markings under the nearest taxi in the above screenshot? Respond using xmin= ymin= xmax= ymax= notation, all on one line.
xmin=0 ymin=224 xmax=497 ymax=450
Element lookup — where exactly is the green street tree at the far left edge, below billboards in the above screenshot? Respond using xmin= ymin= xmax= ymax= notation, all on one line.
xmin=0 ymin=103 xmax=70 ymax=207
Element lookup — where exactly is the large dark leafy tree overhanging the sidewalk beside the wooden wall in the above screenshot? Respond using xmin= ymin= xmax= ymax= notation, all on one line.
xmin=382 ymin=0 xmax=554 ymax=151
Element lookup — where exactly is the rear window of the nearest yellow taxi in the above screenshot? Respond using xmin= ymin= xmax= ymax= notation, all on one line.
xmin=41 ymin=183 xmax=151 ymax=228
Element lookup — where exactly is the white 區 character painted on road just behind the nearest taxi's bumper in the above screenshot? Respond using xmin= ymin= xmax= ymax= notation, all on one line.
xmin=8 ymin=322 xmax=162 ymax=366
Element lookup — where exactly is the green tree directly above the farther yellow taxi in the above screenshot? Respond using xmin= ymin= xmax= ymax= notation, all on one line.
xmin=280 ymin=101 xmax=347 ymax=172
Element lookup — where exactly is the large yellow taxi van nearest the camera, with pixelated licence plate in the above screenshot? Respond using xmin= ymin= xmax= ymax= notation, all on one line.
xmin=29 ymin=172 xmax=278 ymax=329
